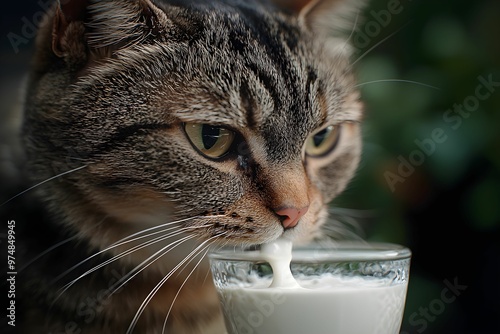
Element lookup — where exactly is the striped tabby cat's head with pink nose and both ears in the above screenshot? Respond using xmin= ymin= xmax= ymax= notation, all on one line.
xmin=25 ymin=0 xmax=362 ymax=249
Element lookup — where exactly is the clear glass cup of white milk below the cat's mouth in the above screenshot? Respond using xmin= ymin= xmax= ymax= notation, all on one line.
xmin=209 ymin=242 xmax=411 ymax=334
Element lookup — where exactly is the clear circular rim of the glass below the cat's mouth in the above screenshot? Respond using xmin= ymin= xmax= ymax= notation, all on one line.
xmin=208 ymin=241 xmax=412 ymax=263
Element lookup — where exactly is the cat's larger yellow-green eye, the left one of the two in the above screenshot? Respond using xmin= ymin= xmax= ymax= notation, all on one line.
xmin=184 ymin=123 xmax=235 ymax=159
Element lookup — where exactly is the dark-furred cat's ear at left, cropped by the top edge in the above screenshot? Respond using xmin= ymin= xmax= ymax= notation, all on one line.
xmin=52 ymin=0 xmax=169 ymax=60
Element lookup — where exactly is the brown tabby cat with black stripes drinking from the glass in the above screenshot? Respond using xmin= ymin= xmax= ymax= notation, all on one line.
xmin=9 ymin=0 xmax=363 ymax=334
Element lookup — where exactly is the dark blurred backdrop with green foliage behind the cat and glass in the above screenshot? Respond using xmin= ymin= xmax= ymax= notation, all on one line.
xmin=0 ymin=0 xmax=500 ymax=334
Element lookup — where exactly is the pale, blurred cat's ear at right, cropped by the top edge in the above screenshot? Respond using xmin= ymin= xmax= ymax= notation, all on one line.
xmin=274 ymin=0 xmax=366 ymax=37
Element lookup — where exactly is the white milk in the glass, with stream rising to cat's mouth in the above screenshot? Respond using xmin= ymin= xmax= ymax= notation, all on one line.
xmin=219 ymin=241 xmax=407 ymax=334
